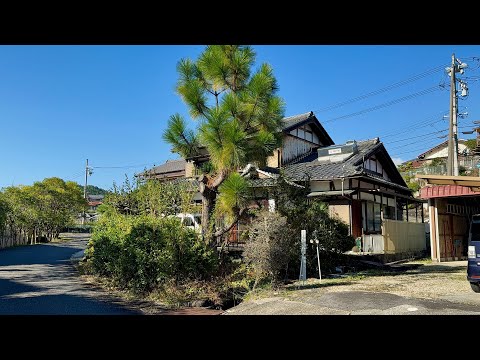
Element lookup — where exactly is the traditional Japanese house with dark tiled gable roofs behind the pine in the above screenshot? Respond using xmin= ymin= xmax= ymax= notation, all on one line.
xmin=142 ymin=112 xmax=426 ymax=254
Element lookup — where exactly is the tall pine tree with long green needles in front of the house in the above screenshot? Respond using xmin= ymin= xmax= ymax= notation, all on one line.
xmin=163 ymin=45 xmax=284 ymax=240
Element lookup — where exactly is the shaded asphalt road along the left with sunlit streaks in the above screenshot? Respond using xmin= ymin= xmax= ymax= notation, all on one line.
xmin=0 ymin=236 xmax=141 ymax=315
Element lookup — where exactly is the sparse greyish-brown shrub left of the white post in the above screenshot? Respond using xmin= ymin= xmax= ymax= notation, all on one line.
xmin=243 ymin=211 xmax=296 ymax=289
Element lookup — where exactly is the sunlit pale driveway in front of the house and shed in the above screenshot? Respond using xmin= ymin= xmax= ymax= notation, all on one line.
xmin=225 ymin=261 xmax=480 ymax=315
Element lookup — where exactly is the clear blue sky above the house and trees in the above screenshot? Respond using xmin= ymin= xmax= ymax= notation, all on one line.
xmin=0 ymin=45 xmax=480 ymax=189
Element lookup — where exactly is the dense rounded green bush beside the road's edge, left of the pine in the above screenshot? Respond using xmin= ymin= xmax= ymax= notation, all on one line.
xmin=86 ymin=214 xmax=217 ymax=293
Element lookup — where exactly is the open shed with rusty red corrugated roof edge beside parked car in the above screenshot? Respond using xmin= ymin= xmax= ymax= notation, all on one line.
xmin=416 ymin=174 xmax=480 ymax=262
